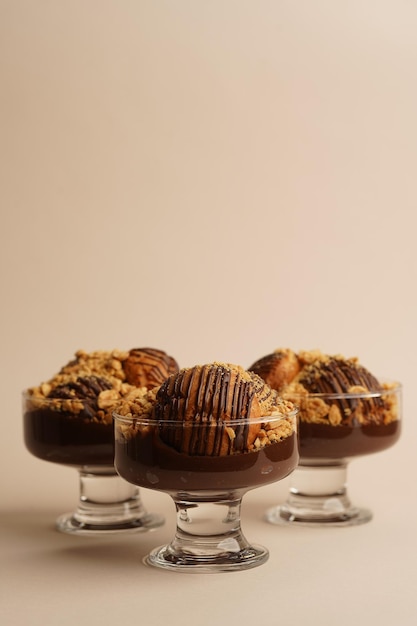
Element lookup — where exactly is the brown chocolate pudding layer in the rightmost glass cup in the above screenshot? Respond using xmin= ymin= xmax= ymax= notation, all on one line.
xmin=299 ymin=420 xmax=400 ymax=460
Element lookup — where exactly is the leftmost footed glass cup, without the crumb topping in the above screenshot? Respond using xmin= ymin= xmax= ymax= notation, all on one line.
xmin=23 ymin=392 xmax=164 ymax=535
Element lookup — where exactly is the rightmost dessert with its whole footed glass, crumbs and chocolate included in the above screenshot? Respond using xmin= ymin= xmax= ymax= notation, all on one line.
xmin=250 ymin=349 xmax=402 ymax=526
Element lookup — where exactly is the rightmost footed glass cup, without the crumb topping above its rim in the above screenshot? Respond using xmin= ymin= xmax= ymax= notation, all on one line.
xmin=265 ymin=384 xmax=401 ymax=527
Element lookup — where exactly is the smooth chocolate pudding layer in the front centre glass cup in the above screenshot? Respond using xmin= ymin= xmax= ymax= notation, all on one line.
xmin=115 ymin=429 xmax=298 ymax=493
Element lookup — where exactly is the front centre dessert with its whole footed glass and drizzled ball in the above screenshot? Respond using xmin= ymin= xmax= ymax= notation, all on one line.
xmin=114 ymin=363 xmax=298 ymax=572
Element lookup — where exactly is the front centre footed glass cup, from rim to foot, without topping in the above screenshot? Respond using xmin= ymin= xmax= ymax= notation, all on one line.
xmin=114 ymin=410 xmax=299 ymax=573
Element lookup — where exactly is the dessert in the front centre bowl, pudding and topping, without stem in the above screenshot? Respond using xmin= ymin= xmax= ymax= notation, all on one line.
xmin=115 ymin=363 xmax=298 ymax=493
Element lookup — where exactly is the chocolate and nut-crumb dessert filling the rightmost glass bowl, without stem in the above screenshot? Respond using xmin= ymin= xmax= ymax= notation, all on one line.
xmin=249 ymin=349 xmax=400 ymax=461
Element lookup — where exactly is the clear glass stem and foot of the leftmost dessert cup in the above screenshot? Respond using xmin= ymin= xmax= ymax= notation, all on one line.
xmin=56 ymin=466 xmax=164 ymax=535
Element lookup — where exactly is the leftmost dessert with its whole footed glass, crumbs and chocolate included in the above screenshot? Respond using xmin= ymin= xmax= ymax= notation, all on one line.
xmin=23 ymin=348 xmax=179 ymax=535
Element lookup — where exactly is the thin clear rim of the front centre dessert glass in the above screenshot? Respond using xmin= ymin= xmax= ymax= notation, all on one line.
xmin=112 ymin=407 xmax=300 ymax=428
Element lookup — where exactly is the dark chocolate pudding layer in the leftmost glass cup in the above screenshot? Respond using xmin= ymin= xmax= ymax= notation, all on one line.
xmin=23 ymin=409 xmax=114 ymax=466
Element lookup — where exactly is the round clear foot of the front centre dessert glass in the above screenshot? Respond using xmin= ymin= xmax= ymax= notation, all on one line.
xmin=143 ymin=544 xmax=269 ymax=574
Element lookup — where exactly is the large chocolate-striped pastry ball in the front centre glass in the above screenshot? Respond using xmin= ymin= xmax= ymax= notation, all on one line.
xmin=155 ymin=364 xmax=255 ymax=456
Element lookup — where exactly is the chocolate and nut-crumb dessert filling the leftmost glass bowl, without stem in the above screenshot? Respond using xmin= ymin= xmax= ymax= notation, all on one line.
xmin=23 ymin=348 xmax=179 ymax=466
